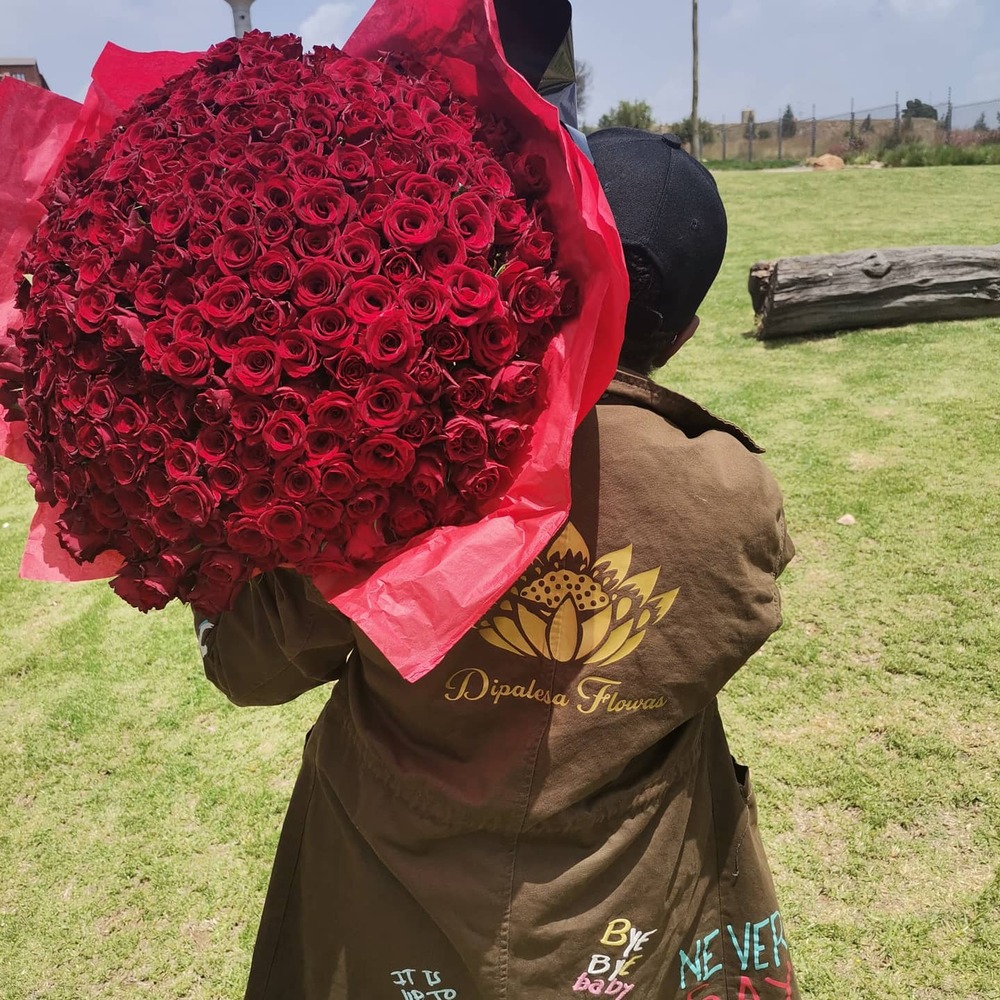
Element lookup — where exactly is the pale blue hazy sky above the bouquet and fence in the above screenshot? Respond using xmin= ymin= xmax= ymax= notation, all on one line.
xmin=0 ymin=0 xmax=1000 ymax=124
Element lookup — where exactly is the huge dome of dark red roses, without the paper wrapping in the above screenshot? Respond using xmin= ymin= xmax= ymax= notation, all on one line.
xmin=5 ymin=32 xmax=577 ymax=613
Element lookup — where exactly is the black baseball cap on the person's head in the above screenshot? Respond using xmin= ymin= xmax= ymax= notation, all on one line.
xmin=587 ymin=128 xmax=727 ymax=333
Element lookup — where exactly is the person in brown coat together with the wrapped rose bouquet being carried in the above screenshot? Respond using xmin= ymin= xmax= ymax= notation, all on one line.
xmin=0 ymin=0 xmax=797 ymax=1000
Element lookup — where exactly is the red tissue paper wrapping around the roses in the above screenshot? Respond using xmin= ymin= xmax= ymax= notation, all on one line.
xmin=0 ymin=0 xmax=628 ymax=681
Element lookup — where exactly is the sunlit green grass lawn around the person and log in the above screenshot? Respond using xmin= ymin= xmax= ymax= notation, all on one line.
xmin=0 ymin=167 xmax=1000 ymax=1000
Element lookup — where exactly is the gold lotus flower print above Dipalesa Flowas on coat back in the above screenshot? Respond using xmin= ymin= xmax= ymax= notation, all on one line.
xmin=477 ymin=522 xmax=680 ymax=666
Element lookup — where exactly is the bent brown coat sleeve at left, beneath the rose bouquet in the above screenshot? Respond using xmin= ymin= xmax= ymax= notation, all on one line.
xmin=195 ymin=569 xmax=354 ymax=705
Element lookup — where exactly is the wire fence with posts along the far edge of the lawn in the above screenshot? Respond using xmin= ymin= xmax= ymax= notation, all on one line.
xmin=684 ymin=98 xmax=1000 ymax=162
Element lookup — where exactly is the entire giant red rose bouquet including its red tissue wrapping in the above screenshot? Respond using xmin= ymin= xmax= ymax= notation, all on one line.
xmin=0 ymin=0 xmax=624 ymax=677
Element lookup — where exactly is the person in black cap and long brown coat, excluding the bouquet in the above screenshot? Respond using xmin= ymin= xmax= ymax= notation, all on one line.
xmin=199 ymin=129 xmax=798 ymax=1000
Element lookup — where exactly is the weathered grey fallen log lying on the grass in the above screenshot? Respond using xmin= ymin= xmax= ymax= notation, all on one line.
xmin=749 ymin=244 xmax=1000 ymax=340
